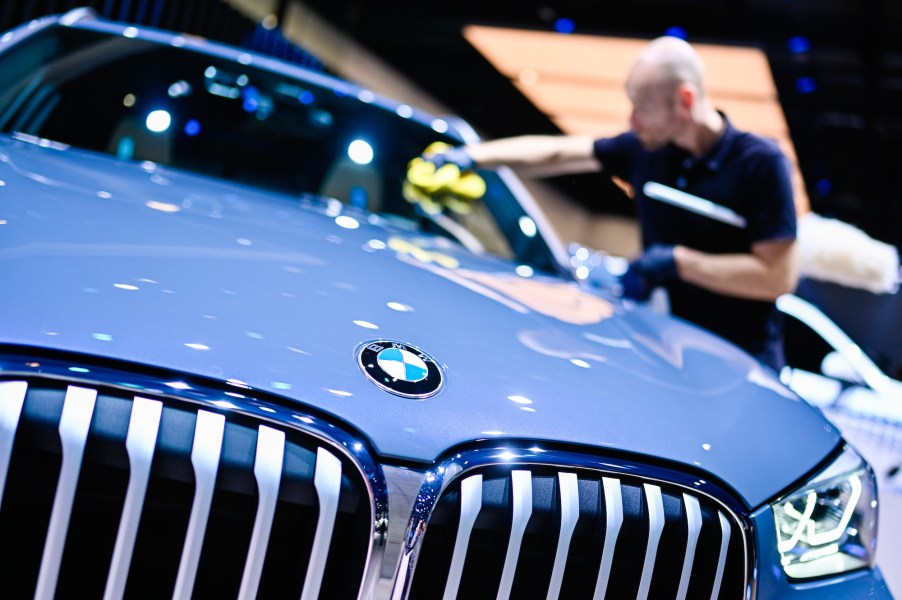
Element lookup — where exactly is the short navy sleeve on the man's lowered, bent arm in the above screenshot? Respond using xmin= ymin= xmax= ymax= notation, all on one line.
xmin=745 ymin=151 xmax=796 ymax=243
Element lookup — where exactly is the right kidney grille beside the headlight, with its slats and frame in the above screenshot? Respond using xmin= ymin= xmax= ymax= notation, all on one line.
xmin=410 ymin=448 xmax=750 ymax=600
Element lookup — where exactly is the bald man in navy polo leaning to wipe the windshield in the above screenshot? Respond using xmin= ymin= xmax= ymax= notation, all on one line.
xmin=430 ymin=37 xmax=798 ymax=369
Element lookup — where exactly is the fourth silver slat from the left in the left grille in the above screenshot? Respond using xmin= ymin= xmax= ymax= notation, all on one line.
xmin=172 ymin=410 xmax=225 ymax=600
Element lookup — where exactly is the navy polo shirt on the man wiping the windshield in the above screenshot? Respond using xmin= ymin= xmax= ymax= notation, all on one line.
xmin=595 ymin=116 xmax=796 ymax=369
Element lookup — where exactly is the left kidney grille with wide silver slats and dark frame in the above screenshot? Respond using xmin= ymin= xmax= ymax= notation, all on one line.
xmin=0 ymin=370 xmax=378 ymax=599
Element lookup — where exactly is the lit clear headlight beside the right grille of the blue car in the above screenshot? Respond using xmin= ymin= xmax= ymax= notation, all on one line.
xmin=772 ymin=446 xmax=877 ymax=579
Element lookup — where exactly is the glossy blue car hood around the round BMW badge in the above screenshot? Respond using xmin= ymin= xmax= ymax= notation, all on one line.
xmin=0 ymin=139 xmax=839 ymax=506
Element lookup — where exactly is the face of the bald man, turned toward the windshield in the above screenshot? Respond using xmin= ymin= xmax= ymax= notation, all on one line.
xmin=626 ymin=68 xmax=681 ymax=150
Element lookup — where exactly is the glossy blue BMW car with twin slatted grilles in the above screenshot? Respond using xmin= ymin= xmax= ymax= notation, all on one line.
xmin=0 ymin=10 xmax=890 ymax=600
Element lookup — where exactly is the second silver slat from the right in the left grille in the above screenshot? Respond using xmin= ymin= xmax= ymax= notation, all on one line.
xmin=238 ymin=425 xmax=285 ymax=599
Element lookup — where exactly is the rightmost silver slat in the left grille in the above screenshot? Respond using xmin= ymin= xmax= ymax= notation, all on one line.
xmin=301 ymin=448 xmax=341 ymax=600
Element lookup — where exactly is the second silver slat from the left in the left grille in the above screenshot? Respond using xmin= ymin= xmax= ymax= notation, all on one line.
xmin=34 ymin=385 xmax=97 ymax=600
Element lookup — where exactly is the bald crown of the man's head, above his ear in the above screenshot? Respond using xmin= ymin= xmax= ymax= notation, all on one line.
xmin=629 ymin=36 xmax=705 ymax=101
